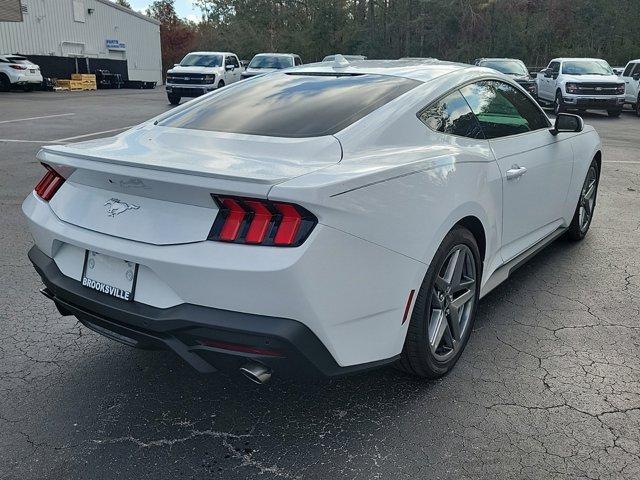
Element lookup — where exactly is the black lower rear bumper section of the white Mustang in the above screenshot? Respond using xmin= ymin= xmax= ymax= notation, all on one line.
xmin=29 ymin=247 xmax=397 ymax=377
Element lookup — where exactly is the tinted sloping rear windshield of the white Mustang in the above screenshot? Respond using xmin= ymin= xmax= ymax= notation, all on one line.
xmin=160 ymin=73 xmax=420 ymax=137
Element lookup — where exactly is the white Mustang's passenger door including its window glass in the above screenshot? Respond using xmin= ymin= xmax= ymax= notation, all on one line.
xmin=460 ymin=80 xmax=573 ymax=261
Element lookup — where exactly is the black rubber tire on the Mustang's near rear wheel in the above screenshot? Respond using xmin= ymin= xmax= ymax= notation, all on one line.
xmin=397 ymin=227 xmax=482 ymax=378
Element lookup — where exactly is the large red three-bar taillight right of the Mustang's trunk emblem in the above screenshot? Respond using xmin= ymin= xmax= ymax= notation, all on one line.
xmin=209 ymin=195 xmax=318 ymax=247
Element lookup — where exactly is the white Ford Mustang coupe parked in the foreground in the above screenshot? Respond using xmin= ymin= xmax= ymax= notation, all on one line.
xmin=22 ymin=60 xmax=601 ymax=383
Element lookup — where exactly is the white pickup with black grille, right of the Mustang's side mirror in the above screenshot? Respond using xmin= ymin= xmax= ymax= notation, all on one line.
xmin=536 ymin=58 xmax=626 ymax=117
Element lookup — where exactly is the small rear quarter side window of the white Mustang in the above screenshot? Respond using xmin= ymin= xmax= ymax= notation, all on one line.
xmin=418 ymin=91 xmax=484 ymax=138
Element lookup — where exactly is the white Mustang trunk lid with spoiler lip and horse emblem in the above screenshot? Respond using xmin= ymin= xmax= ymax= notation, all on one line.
xmin=38 ymin=125 xmax=342 ymax=245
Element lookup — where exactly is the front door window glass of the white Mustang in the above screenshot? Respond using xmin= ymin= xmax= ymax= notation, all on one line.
xmin=460 ymin=80 xmax=549 ymax=138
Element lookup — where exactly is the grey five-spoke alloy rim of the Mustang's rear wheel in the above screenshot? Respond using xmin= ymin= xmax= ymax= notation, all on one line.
xmin=428 ymin=244 xmax=477 ymax=361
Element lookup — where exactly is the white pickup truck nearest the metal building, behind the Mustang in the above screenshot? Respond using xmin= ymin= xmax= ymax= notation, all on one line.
xmin=166 ymin=52 xmax=242 ymax=105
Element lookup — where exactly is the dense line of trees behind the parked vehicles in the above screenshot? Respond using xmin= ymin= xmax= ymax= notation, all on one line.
xmin=141 ymin=0 xmax=640 ymax=72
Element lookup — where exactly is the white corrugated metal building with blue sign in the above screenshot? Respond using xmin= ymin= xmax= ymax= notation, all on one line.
xmin=0 ymin=0 xmax=162 ymax=84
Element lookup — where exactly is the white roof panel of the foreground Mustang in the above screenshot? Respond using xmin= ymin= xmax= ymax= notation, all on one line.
xmin=292 ymin=60 xmax=468 ymax=82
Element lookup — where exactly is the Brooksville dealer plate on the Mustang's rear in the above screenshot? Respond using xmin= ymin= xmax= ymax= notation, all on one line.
xmin=82 ymin=250 xmax=138 ymax=301
